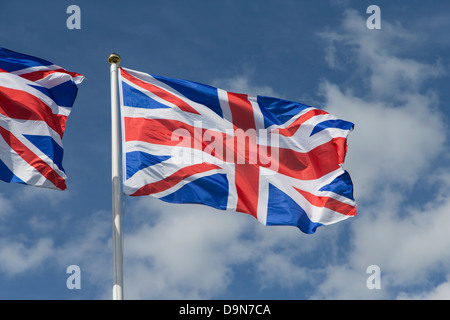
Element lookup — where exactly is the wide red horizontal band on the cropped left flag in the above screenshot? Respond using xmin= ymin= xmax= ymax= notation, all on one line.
xmin=0 ymin=87 xmax=67 ymax=137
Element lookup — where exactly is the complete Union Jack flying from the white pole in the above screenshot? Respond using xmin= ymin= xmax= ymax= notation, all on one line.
xmin=119 ymin=68 xmax=356 ymax=233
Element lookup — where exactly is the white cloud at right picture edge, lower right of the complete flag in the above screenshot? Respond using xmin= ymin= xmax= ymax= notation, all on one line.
xmin=350 ymin=185 xmax=450 ymax=286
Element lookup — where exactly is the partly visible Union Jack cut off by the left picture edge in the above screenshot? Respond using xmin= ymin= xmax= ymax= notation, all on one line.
xmin=0 ymin=48 xmax=83 ymax=190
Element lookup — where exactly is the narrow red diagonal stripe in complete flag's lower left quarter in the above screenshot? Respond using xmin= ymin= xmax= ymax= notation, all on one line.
xmin=131 ymin=162 xmax=220 ymax=196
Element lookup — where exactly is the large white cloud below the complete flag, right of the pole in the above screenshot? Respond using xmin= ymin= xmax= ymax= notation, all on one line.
xmin=124 ymin=197 xmax=326 ymax=299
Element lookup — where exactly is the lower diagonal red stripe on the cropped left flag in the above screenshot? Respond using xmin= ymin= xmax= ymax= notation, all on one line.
xmin=0 ymin=127 xmax=67 ymax=190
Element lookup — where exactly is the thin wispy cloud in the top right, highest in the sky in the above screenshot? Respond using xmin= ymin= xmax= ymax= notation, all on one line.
xmin=319 ymin=10 xmax=445 ymax=100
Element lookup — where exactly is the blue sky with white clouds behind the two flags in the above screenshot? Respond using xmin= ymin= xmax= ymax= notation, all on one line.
xmin=0 ymin=0 xmax=450 ymax=299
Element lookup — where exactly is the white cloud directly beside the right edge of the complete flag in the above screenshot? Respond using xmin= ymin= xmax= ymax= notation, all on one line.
xmin=322 ymin=82 xmax=446 ymax=199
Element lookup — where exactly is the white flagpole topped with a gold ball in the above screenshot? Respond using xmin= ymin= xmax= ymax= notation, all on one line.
xmin=108 ymin=53 xmax=123 ymax=300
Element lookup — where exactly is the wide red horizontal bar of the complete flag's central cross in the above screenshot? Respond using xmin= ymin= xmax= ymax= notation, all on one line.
xmin=124 ymin=117 xmax=347 ymax=181
